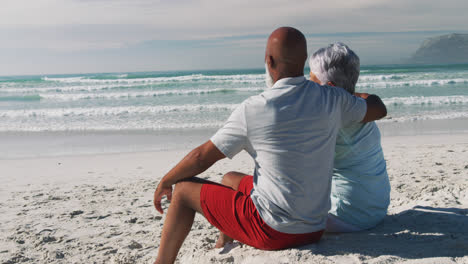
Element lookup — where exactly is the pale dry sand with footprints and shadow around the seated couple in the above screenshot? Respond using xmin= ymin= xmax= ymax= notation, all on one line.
xmin=0 ymin=134 xmax=468 ymax=264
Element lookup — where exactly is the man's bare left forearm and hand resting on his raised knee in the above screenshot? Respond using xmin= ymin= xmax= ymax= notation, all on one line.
xmin=154 ymin=140 xmax=226 ymax=214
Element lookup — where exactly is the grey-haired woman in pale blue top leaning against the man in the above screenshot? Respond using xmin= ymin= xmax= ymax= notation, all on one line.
xmin=309 ymin=43 xmax=390 ymax=232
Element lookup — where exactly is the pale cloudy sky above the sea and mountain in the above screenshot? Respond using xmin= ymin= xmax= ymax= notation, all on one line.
xmin=0 ymin=0 xmax=468 ymax=75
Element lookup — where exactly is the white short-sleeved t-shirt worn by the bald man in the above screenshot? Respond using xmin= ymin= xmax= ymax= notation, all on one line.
xmin=211 ymin=76 xmax=367 ymax=234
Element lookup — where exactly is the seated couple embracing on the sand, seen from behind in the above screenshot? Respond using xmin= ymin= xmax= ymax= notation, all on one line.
xmin=154 ymin=27 xmax=389 ymax=263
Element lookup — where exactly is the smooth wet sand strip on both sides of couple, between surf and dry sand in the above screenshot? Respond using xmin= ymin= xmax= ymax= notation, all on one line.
xmin=0 ymin=119 xmax=468 ymax=160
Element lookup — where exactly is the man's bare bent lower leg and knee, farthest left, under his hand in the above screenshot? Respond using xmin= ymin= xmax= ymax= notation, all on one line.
xmin=154 ymin=179 xmax=206 ymax=264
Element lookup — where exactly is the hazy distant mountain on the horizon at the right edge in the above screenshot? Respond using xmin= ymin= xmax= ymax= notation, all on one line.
xmin=410 ymin=33 xmax=468 ymax=64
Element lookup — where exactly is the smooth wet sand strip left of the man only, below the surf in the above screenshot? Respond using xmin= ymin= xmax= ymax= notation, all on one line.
xmin=0 ymin=129 xmax=216 ymax=160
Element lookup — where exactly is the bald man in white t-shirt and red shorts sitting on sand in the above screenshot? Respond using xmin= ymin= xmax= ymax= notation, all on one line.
xmin=154 ymin=27 xmax=386 ymax=263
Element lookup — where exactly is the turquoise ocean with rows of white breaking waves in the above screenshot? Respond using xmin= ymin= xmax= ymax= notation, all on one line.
xmin=0 ymin=64 xmax=468 ymax=158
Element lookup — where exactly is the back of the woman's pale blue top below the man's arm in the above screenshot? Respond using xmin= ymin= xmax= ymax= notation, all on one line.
xmin=330 ymin=122 xmax=390 ymax=229
